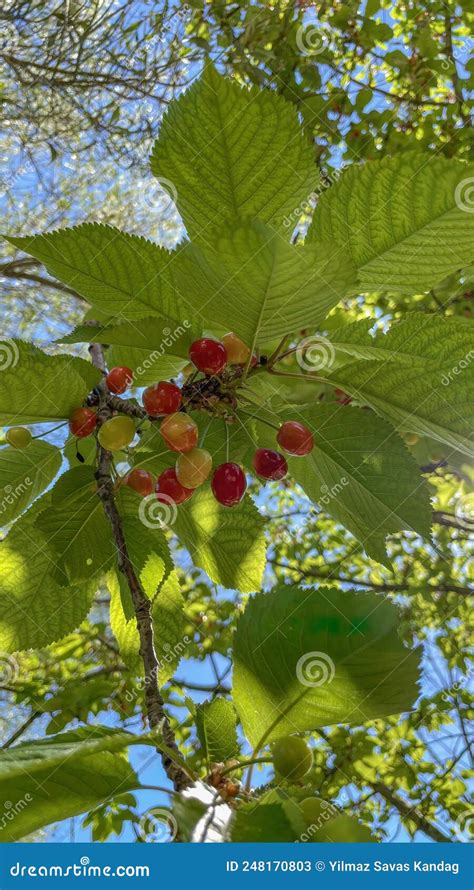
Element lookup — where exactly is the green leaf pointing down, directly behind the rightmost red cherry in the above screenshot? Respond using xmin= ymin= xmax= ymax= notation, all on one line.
xmin=264 ymin=404 xmax=431 ymax=564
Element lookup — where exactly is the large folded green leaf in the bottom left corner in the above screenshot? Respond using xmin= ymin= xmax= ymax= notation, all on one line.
xmin=0 ymin=726 xmax=144 ymax=842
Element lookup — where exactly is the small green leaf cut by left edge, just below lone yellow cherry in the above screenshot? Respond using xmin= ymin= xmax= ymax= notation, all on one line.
xmin=0 ymin=439 xmax=62 ymax=525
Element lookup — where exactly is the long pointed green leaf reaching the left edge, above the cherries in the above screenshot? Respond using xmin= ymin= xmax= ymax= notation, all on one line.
xmin=7 ymin=223 xmax=186 ymax=319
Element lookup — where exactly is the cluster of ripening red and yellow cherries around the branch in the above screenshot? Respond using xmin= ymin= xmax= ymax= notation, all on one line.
xmin=69 ymin=333 xmax=314 ymax=507
